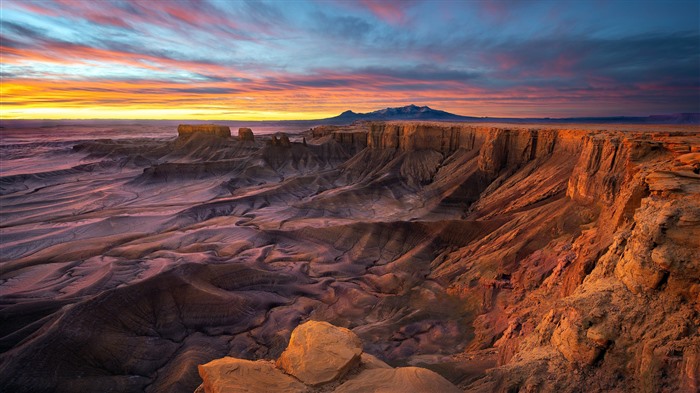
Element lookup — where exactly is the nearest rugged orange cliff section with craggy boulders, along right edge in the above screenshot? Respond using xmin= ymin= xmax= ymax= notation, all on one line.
xmin=460 ymin=128 xmax=700 ymax=392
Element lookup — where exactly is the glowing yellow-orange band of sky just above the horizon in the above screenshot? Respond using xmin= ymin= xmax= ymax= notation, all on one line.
xmin=0 ymin=79 xmax=644 ymax=120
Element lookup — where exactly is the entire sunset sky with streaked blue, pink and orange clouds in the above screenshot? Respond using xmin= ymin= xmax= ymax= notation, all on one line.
xmin=0 ymin=0 xmax=700 ymax=120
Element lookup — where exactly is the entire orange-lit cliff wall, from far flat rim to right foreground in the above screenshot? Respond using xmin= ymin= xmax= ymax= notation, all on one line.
xmin=314 ymin=123 xmax=700 ymax=392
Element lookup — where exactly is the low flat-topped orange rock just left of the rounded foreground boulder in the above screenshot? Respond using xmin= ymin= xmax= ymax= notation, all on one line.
xmin=199 ymin=357 xmax=307 ymax=393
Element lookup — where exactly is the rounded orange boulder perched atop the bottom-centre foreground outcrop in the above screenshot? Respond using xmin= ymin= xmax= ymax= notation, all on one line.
xmin=277 ymin=321 xmax=362 ymax=386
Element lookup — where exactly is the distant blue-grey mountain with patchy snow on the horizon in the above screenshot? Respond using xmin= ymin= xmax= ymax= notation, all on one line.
xmin=324 ymin=105 xmax=478 ymax=122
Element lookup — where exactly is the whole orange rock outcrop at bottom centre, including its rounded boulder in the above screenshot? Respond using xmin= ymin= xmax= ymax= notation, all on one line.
xmin=197 ymin=321 xmax=460 ymax=393
